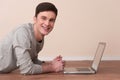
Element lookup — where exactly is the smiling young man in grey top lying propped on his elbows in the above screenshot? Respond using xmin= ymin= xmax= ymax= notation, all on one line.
xmin=0 ymin=2 xmax=64 ymax=74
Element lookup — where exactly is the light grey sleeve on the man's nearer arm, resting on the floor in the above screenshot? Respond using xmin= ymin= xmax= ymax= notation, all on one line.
xmin=13 ymin=28 xmax=42 ymax=74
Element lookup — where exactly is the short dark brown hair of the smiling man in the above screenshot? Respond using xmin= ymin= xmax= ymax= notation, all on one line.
xmin=35 ymin=2 xmax=58 ymax=17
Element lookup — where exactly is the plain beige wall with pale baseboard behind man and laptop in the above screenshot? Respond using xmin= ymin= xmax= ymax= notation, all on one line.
xmin=0 ymin=0 xmax=120 ymax=60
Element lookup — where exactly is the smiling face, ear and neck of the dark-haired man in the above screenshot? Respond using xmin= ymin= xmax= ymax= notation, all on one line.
xmin=34 ymin=11 xmax=56 ymax=41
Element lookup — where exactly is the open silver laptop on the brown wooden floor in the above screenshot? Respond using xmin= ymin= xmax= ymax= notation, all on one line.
xmin=64 ymin=42 xmax=106 ymax=74
